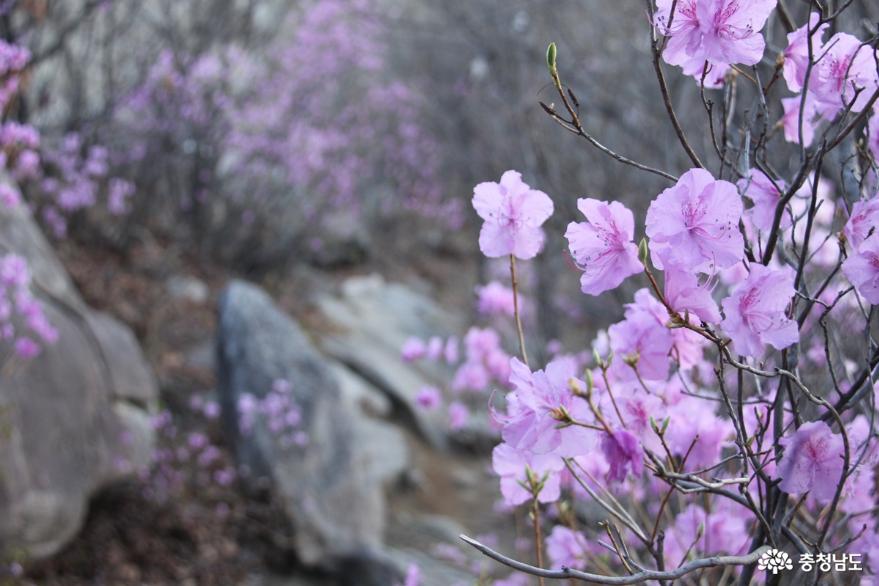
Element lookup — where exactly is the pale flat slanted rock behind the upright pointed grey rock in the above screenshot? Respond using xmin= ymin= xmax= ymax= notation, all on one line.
xmin=317 ymin=275 xmax=462 ymax=446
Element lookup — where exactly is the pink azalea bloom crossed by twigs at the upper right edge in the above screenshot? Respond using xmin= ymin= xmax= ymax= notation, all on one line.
xmin=809 ymin=33 xmax=879 ymax=120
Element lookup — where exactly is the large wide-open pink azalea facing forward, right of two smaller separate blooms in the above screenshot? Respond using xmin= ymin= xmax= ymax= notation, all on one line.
xmin=647 ymin=169 xmax=744 ymax=270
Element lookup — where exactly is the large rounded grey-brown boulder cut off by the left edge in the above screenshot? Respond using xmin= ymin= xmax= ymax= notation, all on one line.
xmin=0 ymin=200 xmax=158 ymax=559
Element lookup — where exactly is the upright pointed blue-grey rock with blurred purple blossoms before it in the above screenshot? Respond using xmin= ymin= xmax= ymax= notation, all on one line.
xmin=217 ymin=281 xmax=403 ymax=584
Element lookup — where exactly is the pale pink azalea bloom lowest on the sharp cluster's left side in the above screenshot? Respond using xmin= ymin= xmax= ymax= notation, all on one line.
xmin=491 ymin=443 xmax=565 ymax=506
